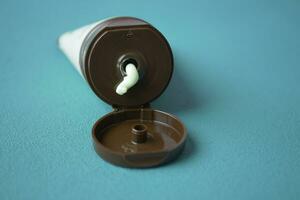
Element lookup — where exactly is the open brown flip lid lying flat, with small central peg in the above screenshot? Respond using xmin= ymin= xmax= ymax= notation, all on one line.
xmin=92 ymin=108 xmax=187 ymax=167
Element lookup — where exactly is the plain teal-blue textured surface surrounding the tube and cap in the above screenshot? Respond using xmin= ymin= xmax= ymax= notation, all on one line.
xmin=0 ymin=0 xmax=300 ymax=200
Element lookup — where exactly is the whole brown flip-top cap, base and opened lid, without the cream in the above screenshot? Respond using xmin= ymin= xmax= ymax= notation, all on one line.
xmin=80 ymin=17 xmax=186 ymax=167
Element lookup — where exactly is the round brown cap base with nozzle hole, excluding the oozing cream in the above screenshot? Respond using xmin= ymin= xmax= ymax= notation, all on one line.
xmin=80 ymin=17 xmax=173 ymax=107
